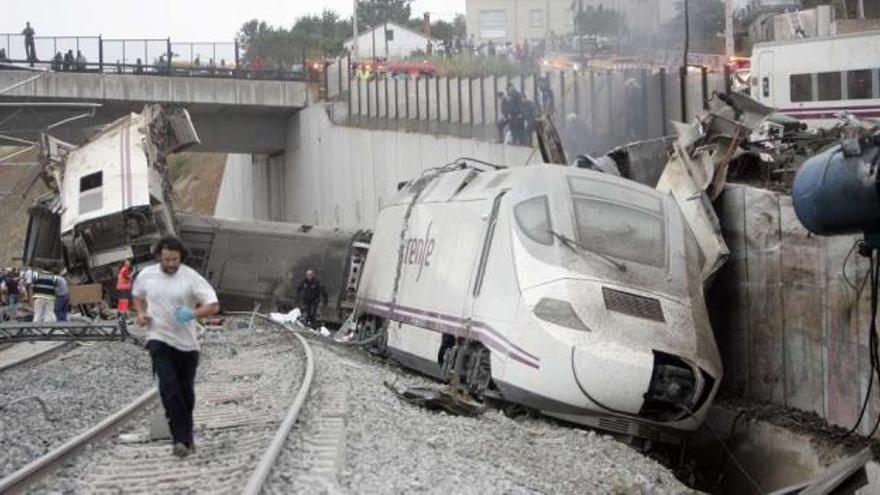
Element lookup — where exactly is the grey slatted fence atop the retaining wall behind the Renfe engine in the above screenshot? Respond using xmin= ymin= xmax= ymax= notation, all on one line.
xmin=334 ymin=61 xmax=730 ymax=156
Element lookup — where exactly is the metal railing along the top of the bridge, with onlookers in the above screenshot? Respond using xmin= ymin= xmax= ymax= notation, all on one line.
xmin=0 ymin=33 xmax=308 ymax=80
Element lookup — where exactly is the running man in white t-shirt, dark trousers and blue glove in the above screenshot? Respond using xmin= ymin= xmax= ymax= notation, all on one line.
xmin=131 ymin=236 xmax=220 ymax=457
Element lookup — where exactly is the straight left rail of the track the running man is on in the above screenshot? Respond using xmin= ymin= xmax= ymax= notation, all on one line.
xmin=0 ymin=387 xmax=159 ymax=493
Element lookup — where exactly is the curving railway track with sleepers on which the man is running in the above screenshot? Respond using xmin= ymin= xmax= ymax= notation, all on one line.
xmin=0 ymin=318 xmax=314 ymax=493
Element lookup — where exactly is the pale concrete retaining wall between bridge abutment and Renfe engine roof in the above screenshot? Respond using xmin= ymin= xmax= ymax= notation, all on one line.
xmin=284 ymin=105 xmax=540 ymax=228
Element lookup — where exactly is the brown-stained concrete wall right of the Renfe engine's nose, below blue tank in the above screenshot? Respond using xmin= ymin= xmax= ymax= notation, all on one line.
xmin=707 ymin=186 xmax=880 ymax=434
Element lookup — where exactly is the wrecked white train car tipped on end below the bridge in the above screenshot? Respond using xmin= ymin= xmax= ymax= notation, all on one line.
xmin=24 ymin=105 xmax=199 ymax=285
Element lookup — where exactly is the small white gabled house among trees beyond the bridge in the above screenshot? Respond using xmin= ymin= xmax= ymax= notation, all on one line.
xmin=344 ymin=22 xmax=438 ymax=60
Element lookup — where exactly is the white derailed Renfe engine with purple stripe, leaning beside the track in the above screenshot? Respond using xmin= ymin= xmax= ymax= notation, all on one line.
xmin=354 ymin=165 xmax=721 ymax=440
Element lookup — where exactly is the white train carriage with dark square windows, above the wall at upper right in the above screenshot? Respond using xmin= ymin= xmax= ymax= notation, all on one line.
xmin=751 ymin=31 xmax=880 ymax=127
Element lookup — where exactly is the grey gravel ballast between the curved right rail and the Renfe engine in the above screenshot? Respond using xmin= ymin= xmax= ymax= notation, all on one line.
xmin=266 ymin=343 xmax=692 ymax=494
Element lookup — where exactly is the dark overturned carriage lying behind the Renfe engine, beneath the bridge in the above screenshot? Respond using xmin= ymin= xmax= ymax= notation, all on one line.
xmin=177 ymin=215 xmax=370 ymax=323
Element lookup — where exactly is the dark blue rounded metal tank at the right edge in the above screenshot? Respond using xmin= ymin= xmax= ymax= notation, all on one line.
xmin=791 ymin=145 xmax=880 ymax=235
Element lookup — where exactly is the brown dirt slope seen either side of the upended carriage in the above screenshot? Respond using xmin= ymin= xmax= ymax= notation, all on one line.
xmin=0 ymin=147 xmax=226 ymax=266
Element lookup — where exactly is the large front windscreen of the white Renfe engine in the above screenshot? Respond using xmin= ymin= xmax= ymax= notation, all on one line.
xmin=572 ymin=196 xmax=666 ymax=268
